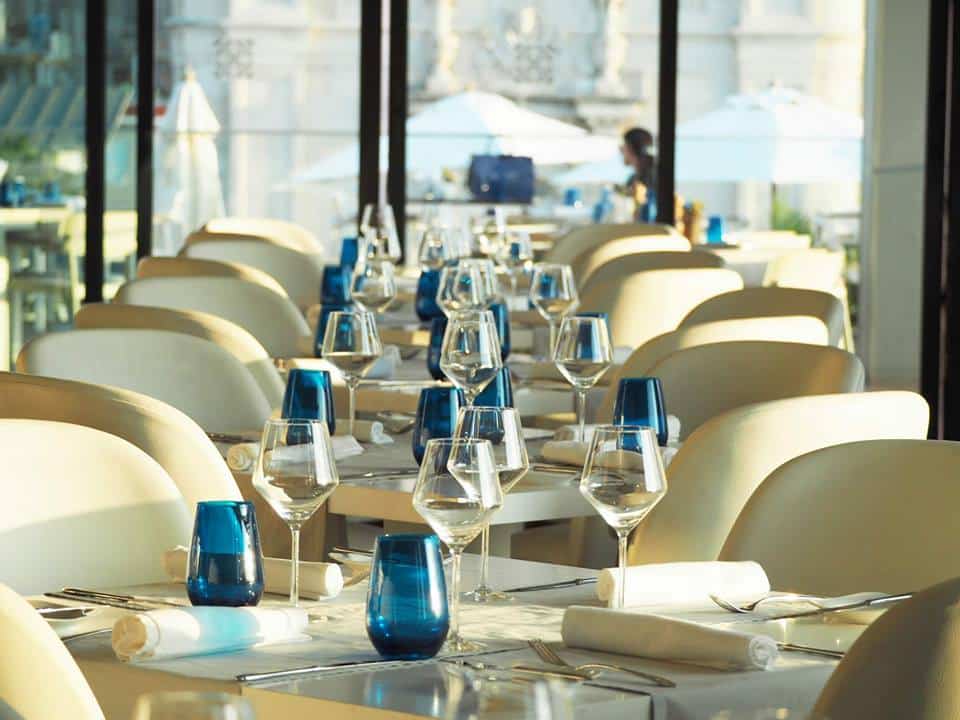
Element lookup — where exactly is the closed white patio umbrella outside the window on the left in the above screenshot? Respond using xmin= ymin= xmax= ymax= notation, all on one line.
xmin=154 ymin=68 xmax=224 ymax=255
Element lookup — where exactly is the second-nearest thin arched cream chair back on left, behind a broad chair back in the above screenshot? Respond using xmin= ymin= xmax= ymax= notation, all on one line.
xmin=74 ymin=303 xmax=284 ymax=409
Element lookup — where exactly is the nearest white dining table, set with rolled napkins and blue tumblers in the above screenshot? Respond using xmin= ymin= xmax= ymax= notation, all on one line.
xmin=56 ymin=555 xmax=848 ymax=720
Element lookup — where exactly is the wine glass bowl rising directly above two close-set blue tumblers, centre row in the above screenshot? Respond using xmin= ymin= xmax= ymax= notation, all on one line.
xmin=440 ymin=310 xmax=503 ymax=405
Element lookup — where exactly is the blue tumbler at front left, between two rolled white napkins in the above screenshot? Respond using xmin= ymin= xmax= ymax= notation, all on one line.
xmin=187 ymin=500 xmax=263 ymax=607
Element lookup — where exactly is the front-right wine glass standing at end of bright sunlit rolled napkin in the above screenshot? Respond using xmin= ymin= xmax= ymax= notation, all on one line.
xmin=580 ymin=425 xmax=667 ymax=608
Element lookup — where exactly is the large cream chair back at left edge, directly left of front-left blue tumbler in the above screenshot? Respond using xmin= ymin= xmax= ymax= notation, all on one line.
xmin=0 ymin=420 xmax=191 ymax=594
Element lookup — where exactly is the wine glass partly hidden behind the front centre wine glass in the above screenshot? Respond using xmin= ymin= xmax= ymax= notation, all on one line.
xmin=455 ymin=407 xmax=530 ymax=602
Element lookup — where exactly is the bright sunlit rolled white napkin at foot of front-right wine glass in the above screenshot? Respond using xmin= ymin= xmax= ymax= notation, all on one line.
xmin=597 ymin=561 xmax=770 ymax=608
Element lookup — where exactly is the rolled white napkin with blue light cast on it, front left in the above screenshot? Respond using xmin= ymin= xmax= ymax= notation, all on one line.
xmin=111 ymin=607 xmax=308 ymax=662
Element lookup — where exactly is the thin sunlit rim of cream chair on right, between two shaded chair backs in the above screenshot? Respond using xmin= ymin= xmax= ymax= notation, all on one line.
xmin=597 ymin=315 xmax=828 ymax=422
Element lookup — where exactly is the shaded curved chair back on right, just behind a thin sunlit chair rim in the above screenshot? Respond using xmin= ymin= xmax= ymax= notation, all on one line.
xmin=680 ymin=287 xmax=845 ymax=345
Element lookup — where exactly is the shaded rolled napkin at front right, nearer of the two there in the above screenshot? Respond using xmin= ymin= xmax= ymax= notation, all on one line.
xmin=561 ymin=605 xmax=779 ymax=670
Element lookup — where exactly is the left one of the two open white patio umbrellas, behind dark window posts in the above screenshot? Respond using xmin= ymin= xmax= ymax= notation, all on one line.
xmin=292 ymin=92 xmax=616 ymax=184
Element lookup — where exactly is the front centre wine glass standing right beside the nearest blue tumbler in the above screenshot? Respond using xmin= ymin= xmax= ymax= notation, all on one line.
xmin=413 ymin=438 xmax=503 ymax=653
